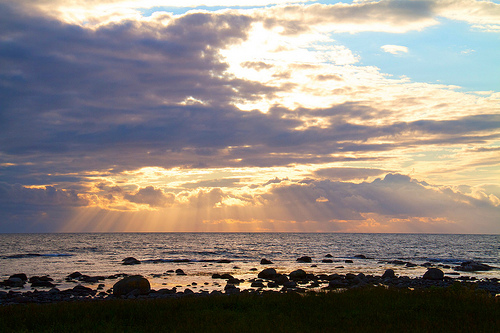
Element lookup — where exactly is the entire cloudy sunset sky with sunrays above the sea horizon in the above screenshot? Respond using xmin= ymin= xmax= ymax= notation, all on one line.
xmin=0 ymin=0 xmax=500 ymax=234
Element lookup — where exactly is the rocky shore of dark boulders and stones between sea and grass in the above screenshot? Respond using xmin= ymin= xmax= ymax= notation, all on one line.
xmin=0 ymin=256 xmax=500 ymax=305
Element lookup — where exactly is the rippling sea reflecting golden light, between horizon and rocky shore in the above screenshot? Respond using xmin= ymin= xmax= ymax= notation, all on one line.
xmin=0 ymin=233 xmax=500 ymax=291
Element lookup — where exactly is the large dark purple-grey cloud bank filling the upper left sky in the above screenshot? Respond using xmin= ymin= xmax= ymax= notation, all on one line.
xmin=0 ymin=4 xmax=500 ymax=185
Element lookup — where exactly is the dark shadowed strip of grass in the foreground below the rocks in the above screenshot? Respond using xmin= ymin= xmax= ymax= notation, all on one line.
xmin=0 ymin=286 xmax=500 ymax=333
